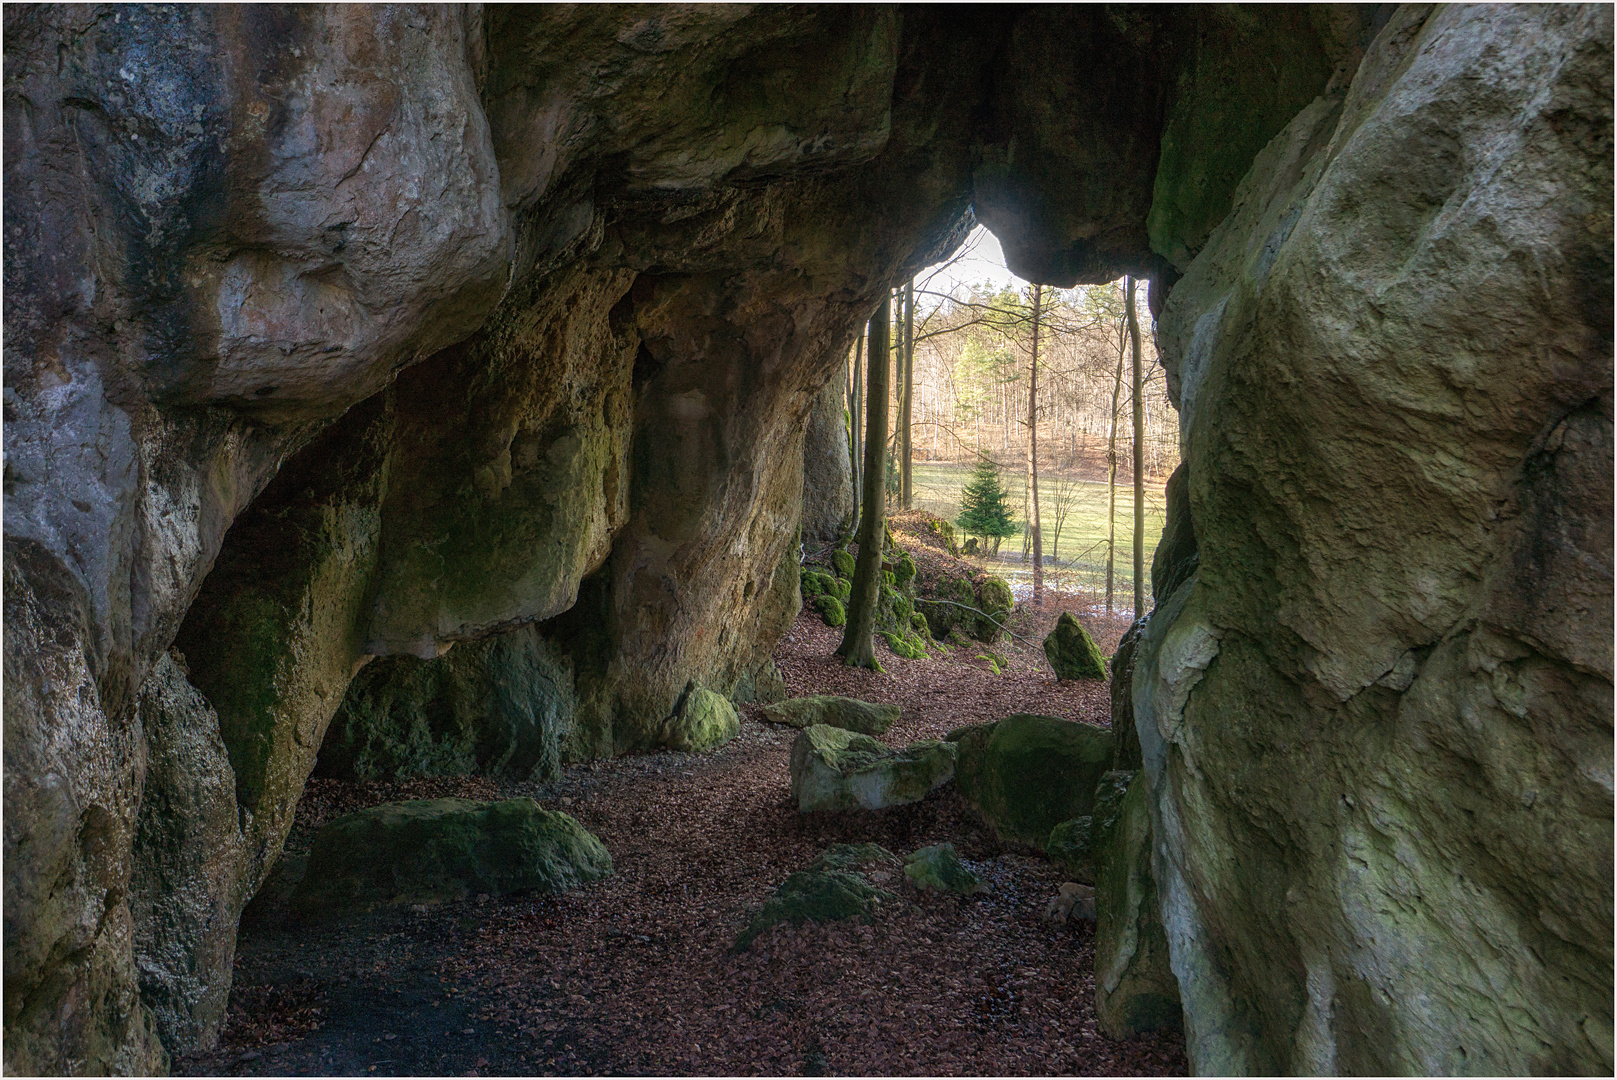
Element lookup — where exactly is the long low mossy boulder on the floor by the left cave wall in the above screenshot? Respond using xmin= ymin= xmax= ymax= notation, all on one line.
xmin=294 ymin=799 xmax=611 ymax=912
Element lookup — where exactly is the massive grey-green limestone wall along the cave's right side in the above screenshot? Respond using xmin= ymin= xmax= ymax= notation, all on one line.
xmin=1132 ymin=6 xmax=1612 ymax=1074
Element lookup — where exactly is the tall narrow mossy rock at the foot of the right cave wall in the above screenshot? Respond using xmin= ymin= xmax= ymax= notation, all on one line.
xmin=1093 ymin=773 xmax=1184 ymax=1038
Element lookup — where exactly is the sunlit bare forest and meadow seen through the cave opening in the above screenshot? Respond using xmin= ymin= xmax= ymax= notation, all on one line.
xmin=844 ymin=232 xmax=1179 ymax=608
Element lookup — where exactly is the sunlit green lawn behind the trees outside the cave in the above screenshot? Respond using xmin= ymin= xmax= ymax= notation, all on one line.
xmin=912 ymin=462 xmax=1166 ymax=608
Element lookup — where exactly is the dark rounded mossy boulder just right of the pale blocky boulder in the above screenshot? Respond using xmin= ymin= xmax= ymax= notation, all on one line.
xmin=951 ymin=713 xmax=1112 ymax=850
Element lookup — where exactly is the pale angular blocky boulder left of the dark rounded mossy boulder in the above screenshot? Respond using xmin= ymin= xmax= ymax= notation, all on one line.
xmin=791 ymin=724 xmax=954 ymax=813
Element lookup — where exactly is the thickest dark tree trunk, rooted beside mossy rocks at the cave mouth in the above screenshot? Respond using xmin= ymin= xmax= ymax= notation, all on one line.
xmin=836 ymin=293 xmax=893 ymax=671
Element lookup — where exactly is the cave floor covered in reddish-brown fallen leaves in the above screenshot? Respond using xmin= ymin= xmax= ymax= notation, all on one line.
xmin=175 ymin=603 xmax=1187 ymax=1075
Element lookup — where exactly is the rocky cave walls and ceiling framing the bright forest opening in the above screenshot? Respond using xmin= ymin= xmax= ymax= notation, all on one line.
xmin=3 ymin=5 xmax=1614 ymax=1075
